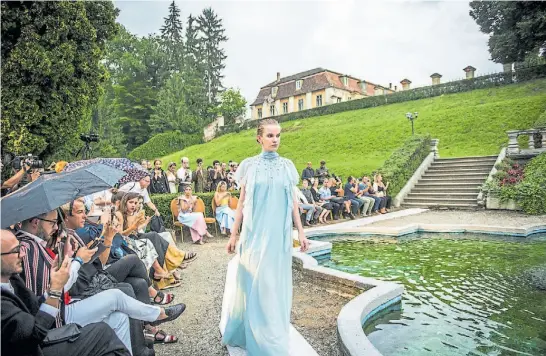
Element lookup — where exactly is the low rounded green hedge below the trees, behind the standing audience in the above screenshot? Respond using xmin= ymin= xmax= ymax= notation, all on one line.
xmin=128 ymin=131 xmax=203 ymax=161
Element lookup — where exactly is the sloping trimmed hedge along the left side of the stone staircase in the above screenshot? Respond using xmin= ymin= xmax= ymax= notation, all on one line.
xmin=378 ymin=135 xmax=431 ymax=198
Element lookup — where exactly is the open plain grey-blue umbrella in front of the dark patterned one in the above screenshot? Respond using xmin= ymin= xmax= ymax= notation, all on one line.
xmin=0 ymin=163 xmax=125 ymax=228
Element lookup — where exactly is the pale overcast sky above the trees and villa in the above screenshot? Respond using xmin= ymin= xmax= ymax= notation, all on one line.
xmin=115 ymin=0 xmax=502 ymax=110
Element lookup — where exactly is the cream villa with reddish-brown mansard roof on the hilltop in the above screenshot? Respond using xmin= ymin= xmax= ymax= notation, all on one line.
xmin=250 ymin=68 xmax=396 ymax=120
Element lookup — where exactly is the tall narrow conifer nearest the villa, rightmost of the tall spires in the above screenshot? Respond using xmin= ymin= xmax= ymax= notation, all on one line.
xmin=197 ymin=8 xmax=228 ymax=105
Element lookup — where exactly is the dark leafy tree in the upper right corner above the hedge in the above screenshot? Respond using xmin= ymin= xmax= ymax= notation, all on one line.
xmin=470 ymin=1 xmax=546 ymax=63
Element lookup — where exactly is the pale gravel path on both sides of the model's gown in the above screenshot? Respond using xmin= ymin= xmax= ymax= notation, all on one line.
xmin=155 ymin=238 xmax=349 ymax=356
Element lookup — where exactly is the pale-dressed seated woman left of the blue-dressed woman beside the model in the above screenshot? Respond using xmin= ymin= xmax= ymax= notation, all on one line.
xmin=178 ymin=185 xmax=212 ymax=245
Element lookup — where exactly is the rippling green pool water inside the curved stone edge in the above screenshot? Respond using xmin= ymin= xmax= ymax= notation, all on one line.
xmin=323 ymin=234 xmax=546 ymax=356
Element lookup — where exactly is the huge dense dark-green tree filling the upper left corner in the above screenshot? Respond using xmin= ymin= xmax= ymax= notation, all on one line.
xmin=1 ymin=1 xmax=117 ymax=158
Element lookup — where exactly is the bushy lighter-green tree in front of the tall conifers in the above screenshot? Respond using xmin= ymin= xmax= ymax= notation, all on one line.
xmin=149 ymin=73 xmax=203 ymax=134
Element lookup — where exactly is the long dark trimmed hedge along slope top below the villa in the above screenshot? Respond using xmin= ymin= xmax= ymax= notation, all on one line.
xmin=217 ymin=65 xmax=546 ymax=136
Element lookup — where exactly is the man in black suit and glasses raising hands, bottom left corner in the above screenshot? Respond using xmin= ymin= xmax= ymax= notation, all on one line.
xmin=0 ymin=230 xmax=130 ymax=356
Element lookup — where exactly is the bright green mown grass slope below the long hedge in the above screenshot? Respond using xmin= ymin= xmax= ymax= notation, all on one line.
xmin=160 ymin=79 xmax=546 ymax=176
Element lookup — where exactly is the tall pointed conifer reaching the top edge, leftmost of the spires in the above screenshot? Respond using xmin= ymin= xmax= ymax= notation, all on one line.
xmin=161 ymin=0 xmax=184 ymax=72
